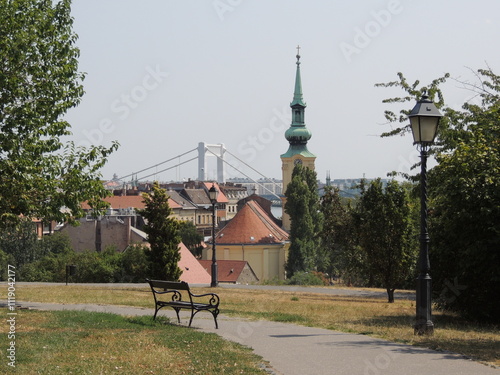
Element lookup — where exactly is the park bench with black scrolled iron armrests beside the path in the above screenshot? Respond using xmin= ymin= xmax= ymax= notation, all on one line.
xmin=146 ymin=279 xmax=220 ymax=328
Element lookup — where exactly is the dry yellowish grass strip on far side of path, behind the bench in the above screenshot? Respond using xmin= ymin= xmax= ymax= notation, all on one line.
xmin=12 ymin=284 xmax=500 ymax=365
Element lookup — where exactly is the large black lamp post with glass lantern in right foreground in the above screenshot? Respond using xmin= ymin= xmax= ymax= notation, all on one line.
xmin=408 ymin=94 xmax=443 ymax=335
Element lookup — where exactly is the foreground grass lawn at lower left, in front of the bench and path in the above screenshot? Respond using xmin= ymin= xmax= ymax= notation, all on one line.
xmin=0 ymin=310 xmax=265 ymax=375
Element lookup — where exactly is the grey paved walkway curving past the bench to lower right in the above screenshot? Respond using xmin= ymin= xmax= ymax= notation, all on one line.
xmin=17 ymin=302 xmax=500 ymax=375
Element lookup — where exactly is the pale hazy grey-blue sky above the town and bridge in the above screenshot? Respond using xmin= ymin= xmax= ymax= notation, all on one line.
xmin=67 ymin=0 xmax=500 ymax=181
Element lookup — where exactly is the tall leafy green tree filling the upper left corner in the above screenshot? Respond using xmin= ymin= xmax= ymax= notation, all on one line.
xmin=0 ymin=0 xmax=117 ymax=224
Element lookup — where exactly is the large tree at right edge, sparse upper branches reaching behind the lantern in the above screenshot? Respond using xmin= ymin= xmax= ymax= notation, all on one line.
xmin=379 ymin=68 xmax=500 ymax=322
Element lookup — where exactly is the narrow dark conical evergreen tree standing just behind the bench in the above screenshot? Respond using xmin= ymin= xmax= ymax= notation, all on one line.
xmin=140 ymin=182 xmax=182 ymax=281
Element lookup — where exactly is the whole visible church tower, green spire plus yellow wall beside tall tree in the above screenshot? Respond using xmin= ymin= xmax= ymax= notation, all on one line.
xmin=281 ymin=46 xmax=316 ymax=231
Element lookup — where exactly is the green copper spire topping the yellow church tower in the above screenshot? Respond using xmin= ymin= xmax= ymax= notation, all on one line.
xmin=281 ymin=46 xmax=315 ymax=157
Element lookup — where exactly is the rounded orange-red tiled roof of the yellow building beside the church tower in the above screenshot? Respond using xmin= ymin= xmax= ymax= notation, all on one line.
xmin=215 ymin=201 xmax=288 ymax=244
